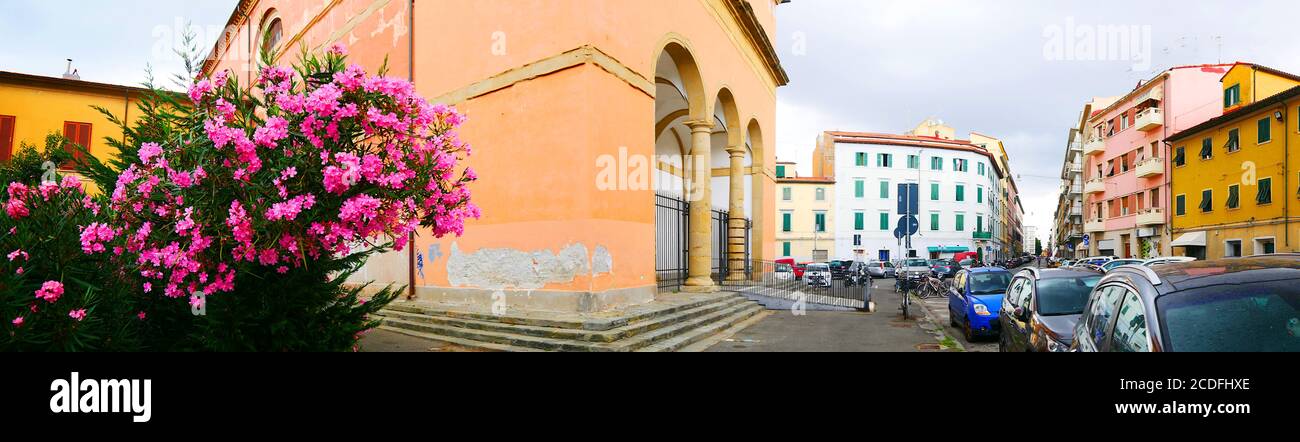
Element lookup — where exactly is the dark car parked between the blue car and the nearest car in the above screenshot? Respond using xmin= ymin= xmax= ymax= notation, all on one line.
xmin=997 ymin=268 xmax=1101 ymax=352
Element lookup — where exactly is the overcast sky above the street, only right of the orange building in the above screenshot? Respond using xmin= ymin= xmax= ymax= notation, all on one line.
xmin=776 ymin=0 xmax=1300 ymax=247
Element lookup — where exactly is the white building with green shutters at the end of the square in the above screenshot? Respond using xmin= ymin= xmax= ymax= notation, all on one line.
xmin=814 ymin=133 xmax=1002 ymax=260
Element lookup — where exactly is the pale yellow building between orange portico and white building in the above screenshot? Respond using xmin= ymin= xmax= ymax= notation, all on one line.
xmin=775 ymin=163 xmax=837 ymax=263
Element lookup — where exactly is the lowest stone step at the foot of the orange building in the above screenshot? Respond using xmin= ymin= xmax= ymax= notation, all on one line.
xmin=384 ymin=299 xmax=762 ymax=352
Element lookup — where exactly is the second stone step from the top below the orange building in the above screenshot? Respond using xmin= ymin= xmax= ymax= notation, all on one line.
xmin=384 ymin=294 xmax=731 ymax=332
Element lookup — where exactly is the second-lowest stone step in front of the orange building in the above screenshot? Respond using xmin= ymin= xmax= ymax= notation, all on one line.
xmin=377 ymin=296 xmax=745 ymax=343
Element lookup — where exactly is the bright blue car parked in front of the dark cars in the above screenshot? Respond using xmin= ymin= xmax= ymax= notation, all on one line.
xmin=948 ymin=267 xmax=1011 ymax=342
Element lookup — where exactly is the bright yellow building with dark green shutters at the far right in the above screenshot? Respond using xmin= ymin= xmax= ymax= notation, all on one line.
xmin=1167 ymin=64 xmax=1300 ymax=259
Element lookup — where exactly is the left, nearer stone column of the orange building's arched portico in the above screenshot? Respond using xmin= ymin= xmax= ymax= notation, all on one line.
xmin=681 ymin=120 xmax=718 ymax=293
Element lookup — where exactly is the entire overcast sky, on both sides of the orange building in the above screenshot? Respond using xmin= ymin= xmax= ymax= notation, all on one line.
xmin=0 ymin=0 xmax=1300 ymax=246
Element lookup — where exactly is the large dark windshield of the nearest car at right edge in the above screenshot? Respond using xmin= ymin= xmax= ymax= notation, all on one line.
xmin=1157 ymin=280 xmax=1300 ymax=352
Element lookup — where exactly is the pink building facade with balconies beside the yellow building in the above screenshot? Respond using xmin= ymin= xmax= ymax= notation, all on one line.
xmin=1083 ymin=65 xmax=1231 ymax=259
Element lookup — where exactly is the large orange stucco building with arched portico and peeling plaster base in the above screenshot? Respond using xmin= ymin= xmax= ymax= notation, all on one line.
xmin=205 ymin=0 xmax=788 ymax=312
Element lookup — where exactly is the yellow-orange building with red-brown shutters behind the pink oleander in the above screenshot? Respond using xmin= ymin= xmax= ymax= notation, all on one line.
xmin=0 ymin=72 xmax=148 ymax=167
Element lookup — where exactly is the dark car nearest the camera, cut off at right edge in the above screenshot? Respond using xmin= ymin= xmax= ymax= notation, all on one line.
xmin=1070 ymin=255 xmax=1300 ymax=352
